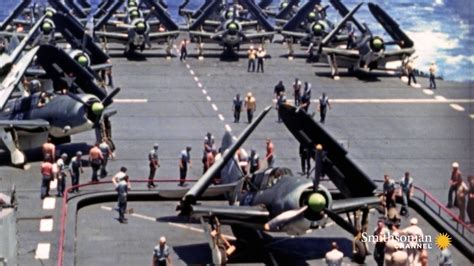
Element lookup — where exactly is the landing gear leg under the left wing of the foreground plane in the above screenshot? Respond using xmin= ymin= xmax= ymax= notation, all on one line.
xmin=201 ymin=217 xmax=235 ymax=265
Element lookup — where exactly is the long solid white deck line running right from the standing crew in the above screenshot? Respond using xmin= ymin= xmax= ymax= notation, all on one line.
xmin=273 ymin=98 xmax=474 ymax=103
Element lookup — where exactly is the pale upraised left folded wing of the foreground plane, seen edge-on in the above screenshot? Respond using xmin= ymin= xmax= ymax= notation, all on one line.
xmin=178 ymin=106 xmax=272 ymax=215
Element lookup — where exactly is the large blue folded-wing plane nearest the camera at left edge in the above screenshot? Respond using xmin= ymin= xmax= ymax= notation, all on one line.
xmin=0 ymin=45 xmax=120 ymax=165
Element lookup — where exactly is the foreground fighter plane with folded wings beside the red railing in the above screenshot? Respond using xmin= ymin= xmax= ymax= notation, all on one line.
xmin=174 ymin=105 xmax=380 ymax=265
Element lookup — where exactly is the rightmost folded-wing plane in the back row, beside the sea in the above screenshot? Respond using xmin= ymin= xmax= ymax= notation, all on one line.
xmin=317 ymin=0 xmax=415 ymax=79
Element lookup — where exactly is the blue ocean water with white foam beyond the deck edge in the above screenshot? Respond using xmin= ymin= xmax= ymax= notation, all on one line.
xmin=0 ymin=0 xmax=474 ymax=81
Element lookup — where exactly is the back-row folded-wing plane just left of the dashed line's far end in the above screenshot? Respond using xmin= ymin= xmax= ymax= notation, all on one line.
xmin=95 ymin=0 xmax=179 ymax=56
